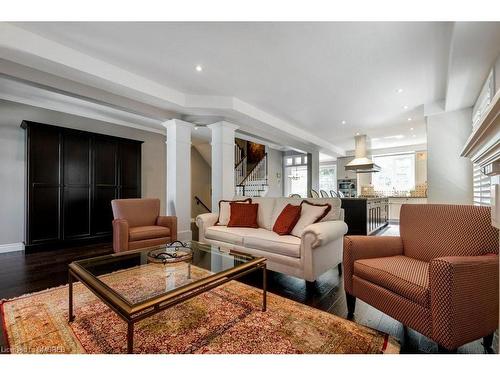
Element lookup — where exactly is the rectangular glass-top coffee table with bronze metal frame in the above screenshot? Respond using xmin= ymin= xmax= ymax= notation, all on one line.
xmin=69 ymin=241 xmax=267 ymax=353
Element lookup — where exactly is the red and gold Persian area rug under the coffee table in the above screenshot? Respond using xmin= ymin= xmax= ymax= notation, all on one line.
xmin=0 ymin=267 xmax=400 ymax=354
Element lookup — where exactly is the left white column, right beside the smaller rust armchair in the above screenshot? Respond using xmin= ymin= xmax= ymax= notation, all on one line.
xmin=163 ymin=119 xmax=193 ymax=241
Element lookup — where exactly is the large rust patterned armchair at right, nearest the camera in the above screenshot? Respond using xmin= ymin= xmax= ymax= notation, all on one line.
xmin=344 ymin=204 xmax=498 ymax=352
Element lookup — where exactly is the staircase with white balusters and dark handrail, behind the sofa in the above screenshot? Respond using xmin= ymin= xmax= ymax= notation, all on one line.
xmin=234 ymin=151 xmax=268 ymax=197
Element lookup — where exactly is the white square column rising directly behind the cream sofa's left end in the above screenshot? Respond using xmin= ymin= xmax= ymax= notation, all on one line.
xmin=208 ymin=121 xmax=238 ymax=212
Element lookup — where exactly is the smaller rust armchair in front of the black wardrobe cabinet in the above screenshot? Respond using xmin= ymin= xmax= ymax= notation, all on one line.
xmin=111 ymin=198 xmax=177 ymax=253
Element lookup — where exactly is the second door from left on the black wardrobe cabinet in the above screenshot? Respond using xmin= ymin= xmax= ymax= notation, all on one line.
xmin=63 ymin=132 xmax=90 ymax=239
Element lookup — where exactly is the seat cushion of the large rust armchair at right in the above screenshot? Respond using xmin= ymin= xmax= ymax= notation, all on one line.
xmin=354 ymin=255 xmax=430 ymax=308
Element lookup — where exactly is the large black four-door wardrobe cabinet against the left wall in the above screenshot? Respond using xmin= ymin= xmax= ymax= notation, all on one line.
xmin=21 ymin=121 xmax=142 ymax=251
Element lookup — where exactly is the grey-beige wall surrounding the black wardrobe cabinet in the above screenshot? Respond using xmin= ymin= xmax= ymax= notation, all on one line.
xmin=0 ymin=100 xmax=166 ymax=245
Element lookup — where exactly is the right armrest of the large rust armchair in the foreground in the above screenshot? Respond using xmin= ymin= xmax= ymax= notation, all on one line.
xmin=429 ymin=254 xmax=499 ymax=349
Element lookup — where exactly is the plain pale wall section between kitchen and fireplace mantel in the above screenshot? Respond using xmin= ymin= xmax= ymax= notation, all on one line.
xmin=427 ymin=108 xmax=472 ymax=204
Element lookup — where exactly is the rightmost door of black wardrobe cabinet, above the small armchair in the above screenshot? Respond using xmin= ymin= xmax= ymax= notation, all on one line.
xmin=119 ymin=142 xmax=141 ymax=198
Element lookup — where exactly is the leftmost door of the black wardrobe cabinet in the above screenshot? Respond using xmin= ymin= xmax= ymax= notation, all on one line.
xmin=27 ymin=126 xmax=61 ymax=245
